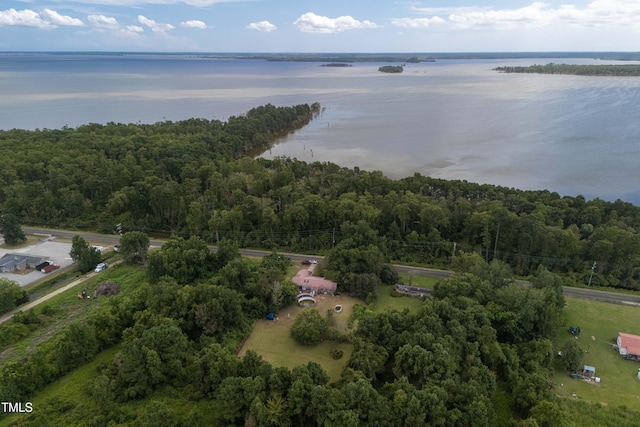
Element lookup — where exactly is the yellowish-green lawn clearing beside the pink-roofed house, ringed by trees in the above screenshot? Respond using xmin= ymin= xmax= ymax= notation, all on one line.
xmin=239 ymin=295 xmax=362 ymax=381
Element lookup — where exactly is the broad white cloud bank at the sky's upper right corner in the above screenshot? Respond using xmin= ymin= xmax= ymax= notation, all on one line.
xmin=408 ymin=0 xmax=640 ymax=29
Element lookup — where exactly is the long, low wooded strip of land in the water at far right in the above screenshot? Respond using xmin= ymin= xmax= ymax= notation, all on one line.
xmin=494 ymin=63 xmax=640 ymax=77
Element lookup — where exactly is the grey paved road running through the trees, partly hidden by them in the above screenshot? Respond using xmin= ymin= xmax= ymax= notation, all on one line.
xmin=15 ymin=227 xmax=640 ymax=307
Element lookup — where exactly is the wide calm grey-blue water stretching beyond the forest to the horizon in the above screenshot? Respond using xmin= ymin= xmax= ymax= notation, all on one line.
xmin=0 ymin=54 xmax=640 ymax=204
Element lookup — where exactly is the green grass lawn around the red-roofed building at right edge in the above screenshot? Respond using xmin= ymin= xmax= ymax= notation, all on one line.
xmin=554 ymin=298 xmax=640 ymax=410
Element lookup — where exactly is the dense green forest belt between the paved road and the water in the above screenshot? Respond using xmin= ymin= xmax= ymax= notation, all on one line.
xmin=0 ymin=100 xmax=640 ymax=289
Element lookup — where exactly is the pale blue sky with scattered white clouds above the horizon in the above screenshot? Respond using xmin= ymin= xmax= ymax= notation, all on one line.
xmin=0 ymin=0 xmax=640 ymax=52
